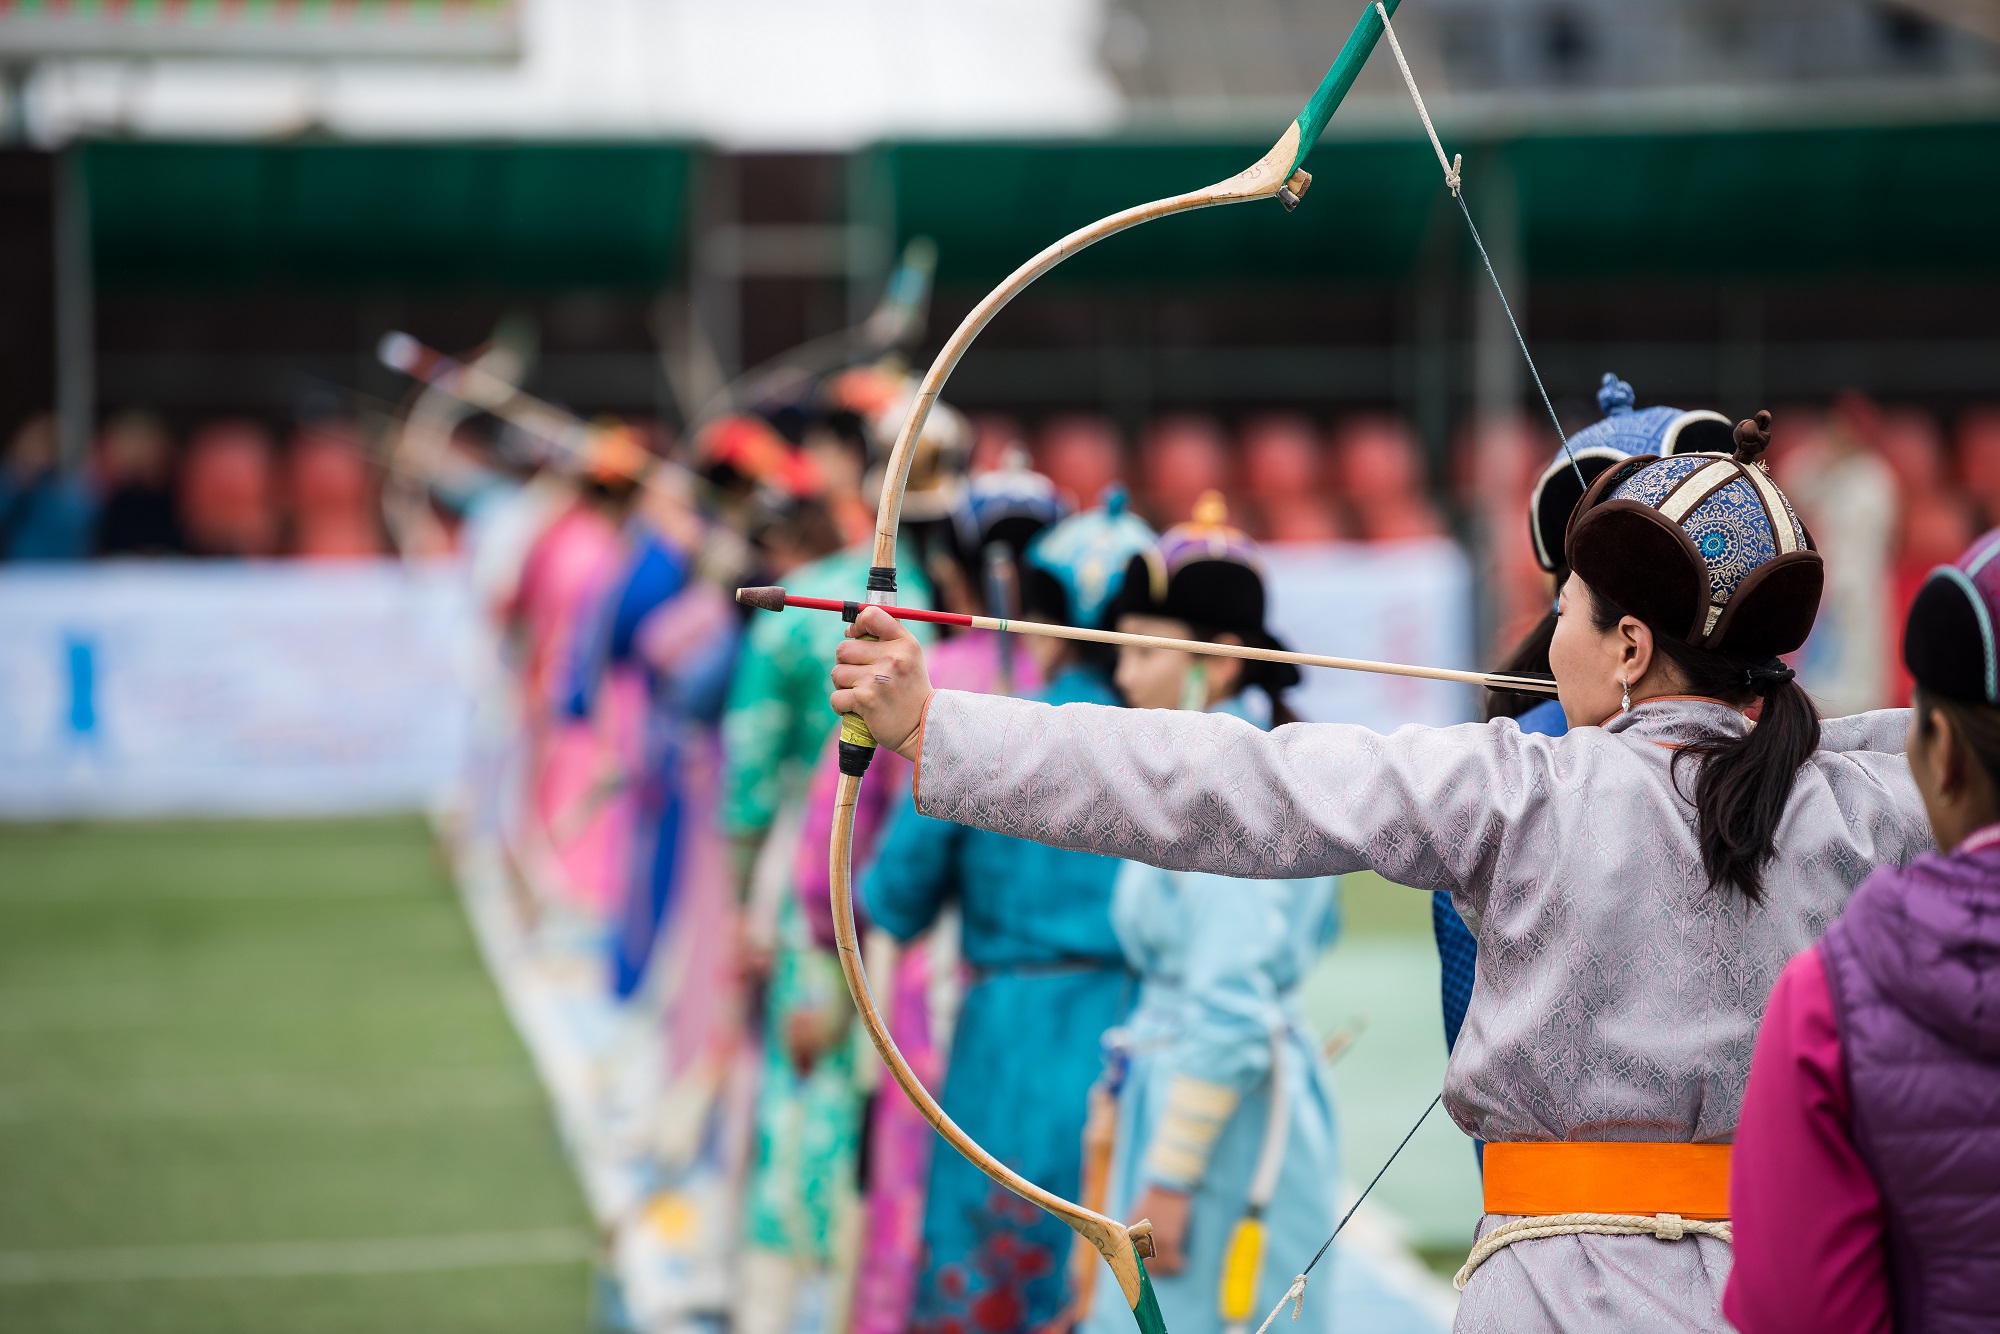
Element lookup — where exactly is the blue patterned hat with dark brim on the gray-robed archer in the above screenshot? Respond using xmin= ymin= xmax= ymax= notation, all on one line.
xmin=1566 ymin=412 xmax=1826 ymax=658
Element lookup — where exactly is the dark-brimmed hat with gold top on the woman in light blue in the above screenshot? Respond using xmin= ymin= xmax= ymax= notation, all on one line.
xmin=1106 ymin=492 xmax=1298 ymax=690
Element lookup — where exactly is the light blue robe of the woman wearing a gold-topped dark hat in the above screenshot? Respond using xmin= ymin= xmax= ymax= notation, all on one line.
xmin=1088 ymin=702 xmax=1340 ymax=1334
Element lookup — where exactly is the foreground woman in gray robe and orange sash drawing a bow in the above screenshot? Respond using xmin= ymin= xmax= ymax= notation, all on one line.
xmin=832 ymin=414 xmax=1930 ymax=1330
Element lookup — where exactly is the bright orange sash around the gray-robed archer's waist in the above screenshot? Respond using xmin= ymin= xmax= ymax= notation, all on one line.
xmin=1486 ymin=1140 xmax=1730 ymax=1218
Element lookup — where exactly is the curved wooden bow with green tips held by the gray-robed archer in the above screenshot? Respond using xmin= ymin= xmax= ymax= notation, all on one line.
xmin=832 ymin=0 xmax=1396 ymax=1334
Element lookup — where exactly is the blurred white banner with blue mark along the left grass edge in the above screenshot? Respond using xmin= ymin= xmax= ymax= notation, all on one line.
xmin=0 ymin=560 xmax=478 ymax=818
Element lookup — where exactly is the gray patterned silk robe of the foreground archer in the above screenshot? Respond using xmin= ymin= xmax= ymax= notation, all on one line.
xmin=916 ymin=690 xmax=1932 ymax=1332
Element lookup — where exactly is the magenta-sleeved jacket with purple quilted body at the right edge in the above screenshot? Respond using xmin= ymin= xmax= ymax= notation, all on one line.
xmin=1722 ymin=826 xmax=2000 ymax=1334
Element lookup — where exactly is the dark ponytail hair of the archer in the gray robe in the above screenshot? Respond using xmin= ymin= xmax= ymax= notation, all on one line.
xmin=1590 ymin=590 xmax=1820 ymax=904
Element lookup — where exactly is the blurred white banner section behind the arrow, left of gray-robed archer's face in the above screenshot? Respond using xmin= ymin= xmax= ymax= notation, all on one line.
xmin=1262 ymin=538 xmax=1478 ymax=732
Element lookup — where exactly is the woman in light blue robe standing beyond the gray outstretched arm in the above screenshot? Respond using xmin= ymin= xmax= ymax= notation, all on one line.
xmin=1084 ymin=492 xmax=1340 ymax=1334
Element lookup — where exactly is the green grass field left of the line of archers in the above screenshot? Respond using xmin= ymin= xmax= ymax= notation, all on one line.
xmin=0 ymin=818 xmax=590 ymax=1334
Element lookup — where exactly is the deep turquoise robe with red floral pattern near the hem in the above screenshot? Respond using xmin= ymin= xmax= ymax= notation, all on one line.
xmin=862 ymin=668 xmax=1136 ymax=1334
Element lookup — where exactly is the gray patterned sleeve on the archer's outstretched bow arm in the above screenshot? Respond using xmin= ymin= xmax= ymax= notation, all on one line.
xmin=918 ymin=690 xmax=1552 ymax=892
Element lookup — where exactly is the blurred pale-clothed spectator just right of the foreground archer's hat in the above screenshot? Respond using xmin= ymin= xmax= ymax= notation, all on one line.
xmin=1770 ymin=410 xmax=1898 ymax=716
